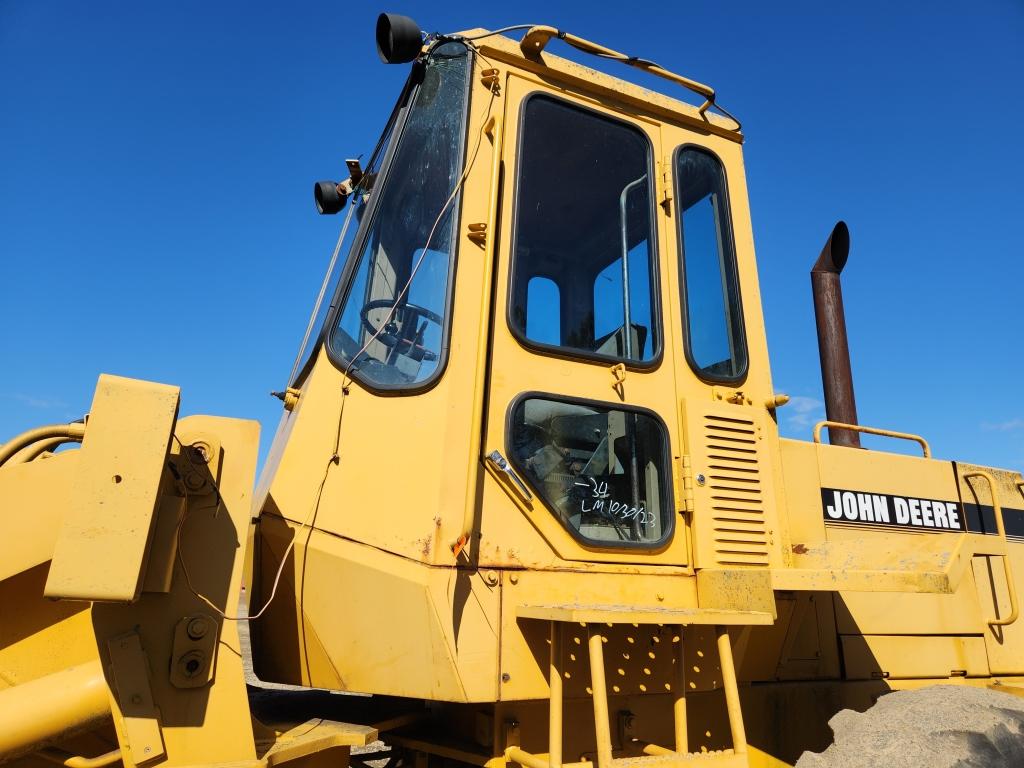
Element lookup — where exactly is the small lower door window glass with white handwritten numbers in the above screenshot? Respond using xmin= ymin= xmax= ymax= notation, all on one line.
xmin=510 ymin=395 xmax=674 ymax=548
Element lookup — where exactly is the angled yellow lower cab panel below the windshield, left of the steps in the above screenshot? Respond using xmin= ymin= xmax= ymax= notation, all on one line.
xmin=251 ymin=516 xmax=499 ymax=701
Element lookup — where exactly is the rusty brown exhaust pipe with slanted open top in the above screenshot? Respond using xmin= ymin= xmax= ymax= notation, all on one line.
xmin=811 ymin=221 xmax=860 ymax=447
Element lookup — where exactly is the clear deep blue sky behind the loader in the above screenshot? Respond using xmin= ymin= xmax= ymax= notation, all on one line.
xmin=0 ymin=0 xmax=1024 ymax=469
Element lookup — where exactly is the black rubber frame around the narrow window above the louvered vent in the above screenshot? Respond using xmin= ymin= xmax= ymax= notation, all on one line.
xmin=672 ymin=142 xmax=751 ymax=385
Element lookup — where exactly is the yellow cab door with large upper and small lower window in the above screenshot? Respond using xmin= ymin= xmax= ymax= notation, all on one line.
xmin=482 ymin=74 xmax=689 ymax=565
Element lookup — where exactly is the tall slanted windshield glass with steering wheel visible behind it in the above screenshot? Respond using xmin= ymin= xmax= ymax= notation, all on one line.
xmin=330 ymin=43 xmax=469 ymax=389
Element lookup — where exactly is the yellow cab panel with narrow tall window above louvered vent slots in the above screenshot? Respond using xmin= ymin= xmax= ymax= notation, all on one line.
xmin=662 ymin=124 xmax=783 ymax=568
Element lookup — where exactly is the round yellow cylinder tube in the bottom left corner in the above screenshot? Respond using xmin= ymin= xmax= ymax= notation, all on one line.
xmin=0 ymin=662 xmax=111 ymax=762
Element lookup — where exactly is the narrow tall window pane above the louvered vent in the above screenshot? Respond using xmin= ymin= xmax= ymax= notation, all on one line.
xmin=676 ymin=147 xmax=746 ymax=382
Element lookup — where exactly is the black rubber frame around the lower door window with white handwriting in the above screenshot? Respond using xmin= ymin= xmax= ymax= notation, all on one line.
xmin=504 ymin=389 xmax=679 ymax=553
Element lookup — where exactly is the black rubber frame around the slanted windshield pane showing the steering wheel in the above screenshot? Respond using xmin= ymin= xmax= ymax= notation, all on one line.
xmin=321 ymin=40 xmax=476 ymax=396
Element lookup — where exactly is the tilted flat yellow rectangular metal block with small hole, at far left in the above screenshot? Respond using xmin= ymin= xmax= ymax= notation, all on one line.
xmin=46 ymin=375 xmax=178 ymax=602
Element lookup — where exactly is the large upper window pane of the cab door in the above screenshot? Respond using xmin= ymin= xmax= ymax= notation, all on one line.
xmin=510 ymin=96 xmax=662 ymax=364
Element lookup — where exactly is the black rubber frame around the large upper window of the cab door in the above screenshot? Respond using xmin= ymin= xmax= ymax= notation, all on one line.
xmin=505 ymin=90 xmax=665 ymax=372
